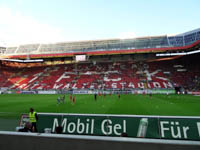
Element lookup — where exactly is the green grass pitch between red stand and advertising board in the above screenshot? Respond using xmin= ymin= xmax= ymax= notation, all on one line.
xmin=0 ymin=94 xmax=200 ymax=119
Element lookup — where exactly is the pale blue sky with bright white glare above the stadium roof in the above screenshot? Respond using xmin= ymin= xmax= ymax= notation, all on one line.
xmin=0 ymin=0 xmax=200 ymax=46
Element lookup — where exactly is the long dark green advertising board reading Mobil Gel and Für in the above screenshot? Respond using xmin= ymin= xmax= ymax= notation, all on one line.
xmin=37 ymin=113 xmax=200 ymax=140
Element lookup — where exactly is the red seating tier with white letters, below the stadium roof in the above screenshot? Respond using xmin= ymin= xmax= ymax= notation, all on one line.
xmin=0 ymin=52 xmax=200 ymax=90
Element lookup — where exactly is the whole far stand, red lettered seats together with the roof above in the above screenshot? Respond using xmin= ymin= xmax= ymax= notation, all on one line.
xmin=0 ymin=29 xmax=200 ymax=91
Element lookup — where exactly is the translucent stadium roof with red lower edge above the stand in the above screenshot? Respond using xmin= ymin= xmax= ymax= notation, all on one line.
xmin=2 ymin=28 xmax=200 ymax=57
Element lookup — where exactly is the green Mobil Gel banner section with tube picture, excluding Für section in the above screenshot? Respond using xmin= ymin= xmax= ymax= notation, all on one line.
xmin=38 ymin=114 xmax=159 ymax=138
